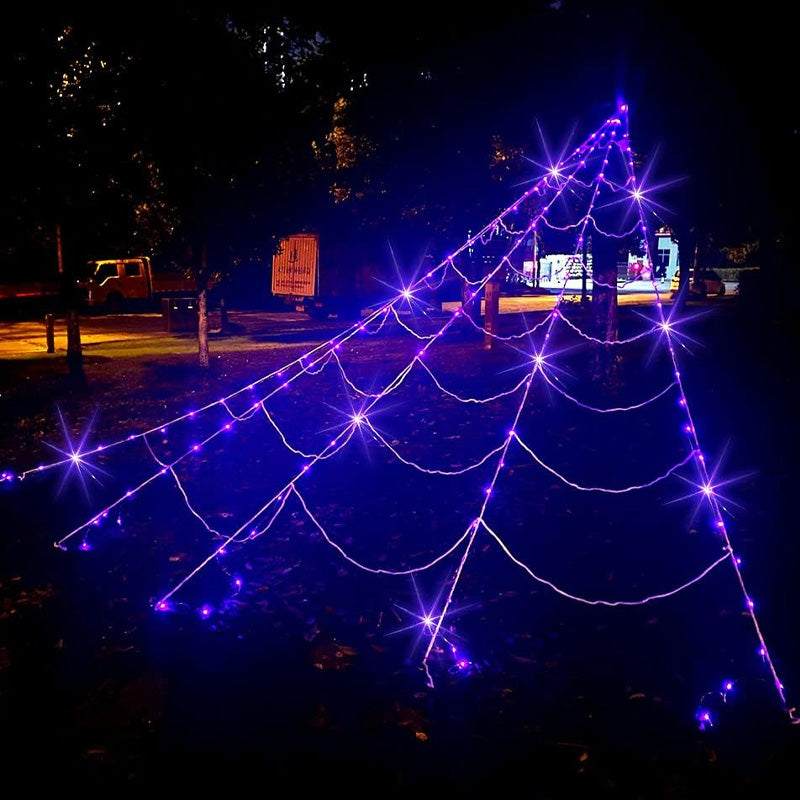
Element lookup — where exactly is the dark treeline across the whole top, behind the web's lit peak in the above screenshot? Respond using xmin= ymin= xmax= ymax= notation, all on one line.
xmin=0 ymin=0 xmax=796 ymax=296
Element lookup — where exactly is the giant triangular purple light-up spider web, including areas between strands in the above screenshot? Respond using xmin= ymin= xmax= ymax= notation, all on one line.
xmin=3 ymin=105 xmax=797 ymax=726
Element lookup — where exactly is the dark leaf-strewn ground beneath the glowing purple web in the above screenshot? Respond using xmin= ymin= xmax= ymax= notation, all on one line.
xmin=0 ymin=304 xmax=800 ymax=798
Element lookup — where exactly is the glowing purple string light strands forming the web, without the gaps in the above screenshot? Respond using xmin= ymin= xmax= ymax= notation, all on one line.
xmin=9 ymin=105 xmax=797 ymax=728
